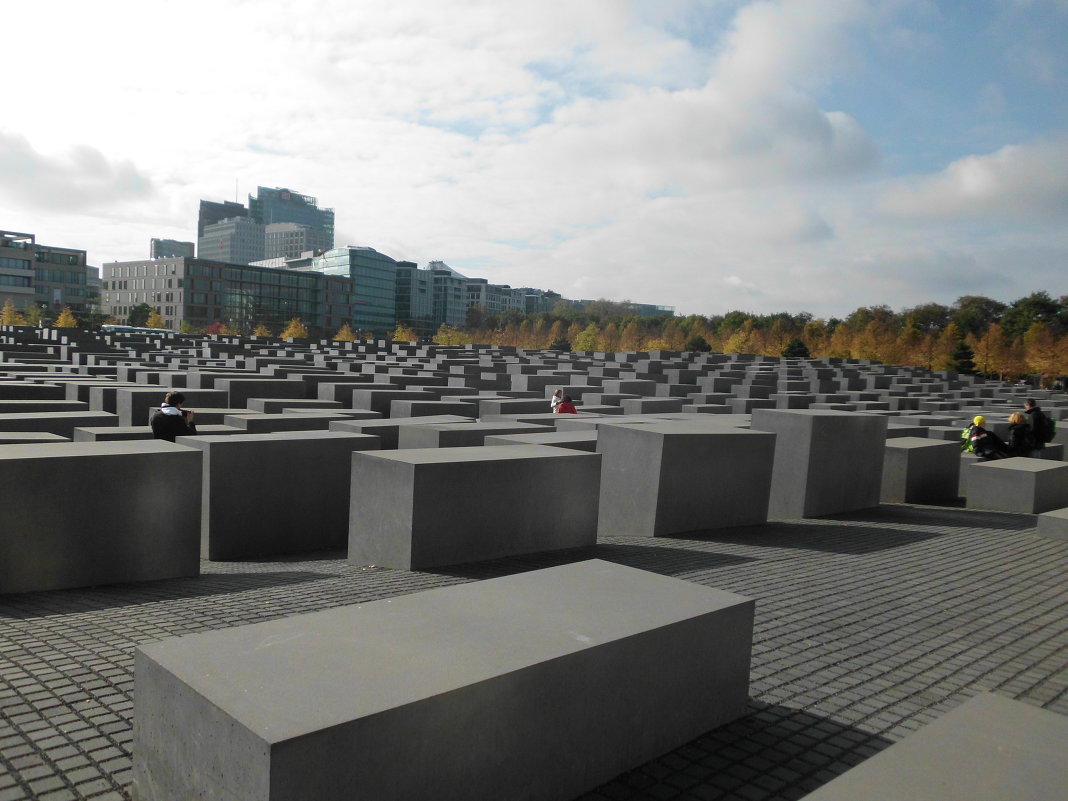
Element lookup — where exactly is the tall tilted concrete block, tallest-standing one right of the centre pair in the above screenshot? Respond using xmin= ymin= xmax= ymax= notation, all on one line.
xmin=751 ymin=409 xmax=886 ymax=518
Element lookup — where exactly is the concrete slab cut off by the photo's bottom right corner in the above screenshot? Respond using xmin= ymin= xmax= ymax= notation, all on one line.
xmin=804 ymin=693 xmax=1068 ymax=801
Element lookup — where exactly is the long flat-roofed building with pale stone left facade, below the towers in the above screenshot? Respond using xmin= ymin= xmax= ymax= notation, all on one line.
xmin=101 ymin=258 xmax=358 ymax=336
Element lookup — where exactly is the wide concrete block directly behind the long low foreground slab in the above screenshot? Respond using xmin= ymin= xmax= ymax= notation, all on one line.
xmin=348 ymin=445 xmax=600 ymax=570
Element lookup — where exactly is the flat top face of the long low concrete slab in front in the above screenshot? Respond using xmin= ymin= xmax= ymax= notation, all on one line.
xmin=135 ymin=559 xmax=753 ymax=742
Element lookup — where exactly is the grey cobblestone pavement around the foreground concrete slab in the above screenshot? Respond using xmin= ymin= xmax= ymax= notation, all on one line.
xmin=0 ymin=505 xmax=1068 ymax=801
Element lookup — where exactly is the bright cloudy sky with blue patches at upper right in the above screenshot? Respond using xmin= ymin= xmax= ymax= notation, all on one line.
xmin=0 ymin=0 xmax=1068 ymax=316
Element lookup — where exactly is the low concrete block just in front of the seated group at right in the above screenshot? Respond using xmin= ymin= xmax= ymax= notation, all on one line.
xmin=965 ymin=456 xmax=1068 ymax=515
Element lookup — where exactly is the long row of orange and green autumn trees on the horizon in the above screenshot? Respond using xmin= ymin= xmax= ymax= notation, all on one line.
xmin=434 ymin=292 xmax=1068 ymax=383
